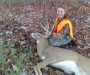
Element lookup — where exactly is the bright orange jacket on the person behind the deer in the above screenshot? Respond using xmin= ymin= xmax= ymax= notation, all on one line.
xmin=53 ymin=18 xmax=74 ymax=39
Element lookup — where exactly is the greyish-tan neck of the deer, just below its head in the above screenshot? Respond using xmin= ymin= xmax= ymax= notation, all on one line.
xmin=37 ymin=39 xmax=48 ymax=57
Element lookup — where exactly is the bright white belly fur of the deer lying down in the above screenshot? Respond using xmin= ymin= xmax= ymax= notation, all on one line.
xmin=52 ymin=60 xmax=87 ymax=75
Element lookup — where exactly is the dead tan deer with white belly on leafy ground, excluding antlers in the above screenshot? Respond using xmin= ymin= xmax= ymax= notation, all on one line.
xmin=31 ymin=33 xmax=90 ymax=75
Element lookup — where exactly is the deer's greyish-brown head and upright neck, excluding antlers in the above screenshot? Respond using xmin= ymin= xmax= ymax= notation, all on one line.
xmin=31 ymin=33 xmax=48 ymax=59
